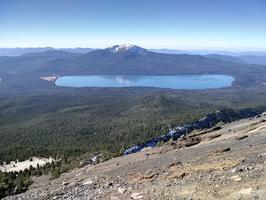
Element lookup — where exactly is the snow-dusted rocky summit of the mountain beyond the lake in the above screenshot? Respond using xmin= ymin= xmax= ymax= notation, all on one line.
xmin=106 ymin=44 xmax=148 ymax=55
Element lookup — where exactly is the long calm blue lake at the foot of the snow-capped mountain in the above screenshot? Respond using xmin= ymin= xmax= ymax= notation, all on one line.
xmin=55 ymin=75 xmax=234 ymax=89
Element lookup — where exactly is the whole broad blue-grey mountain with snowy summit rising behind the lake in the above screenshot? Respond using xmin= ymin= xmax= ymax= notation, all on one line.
xmin=38 ymin=45 xmax=262 ymax=74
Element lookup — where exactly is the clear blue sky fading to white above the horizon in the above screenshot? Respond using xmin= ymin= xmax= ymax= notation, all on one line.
xmin=0 ymin=0 xmax=266 ymax=50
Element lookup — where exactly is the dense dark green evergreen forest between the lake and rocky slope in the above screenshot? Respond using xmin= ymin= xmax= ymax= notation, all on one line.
xmin=0 ymin=88 xmax=266 ymax=163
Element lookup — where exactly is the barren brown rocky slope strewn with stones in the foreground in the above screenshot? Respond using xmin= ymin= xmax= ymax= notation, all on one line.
xmin=5 ymin=113 xmax=266 ymax=200
